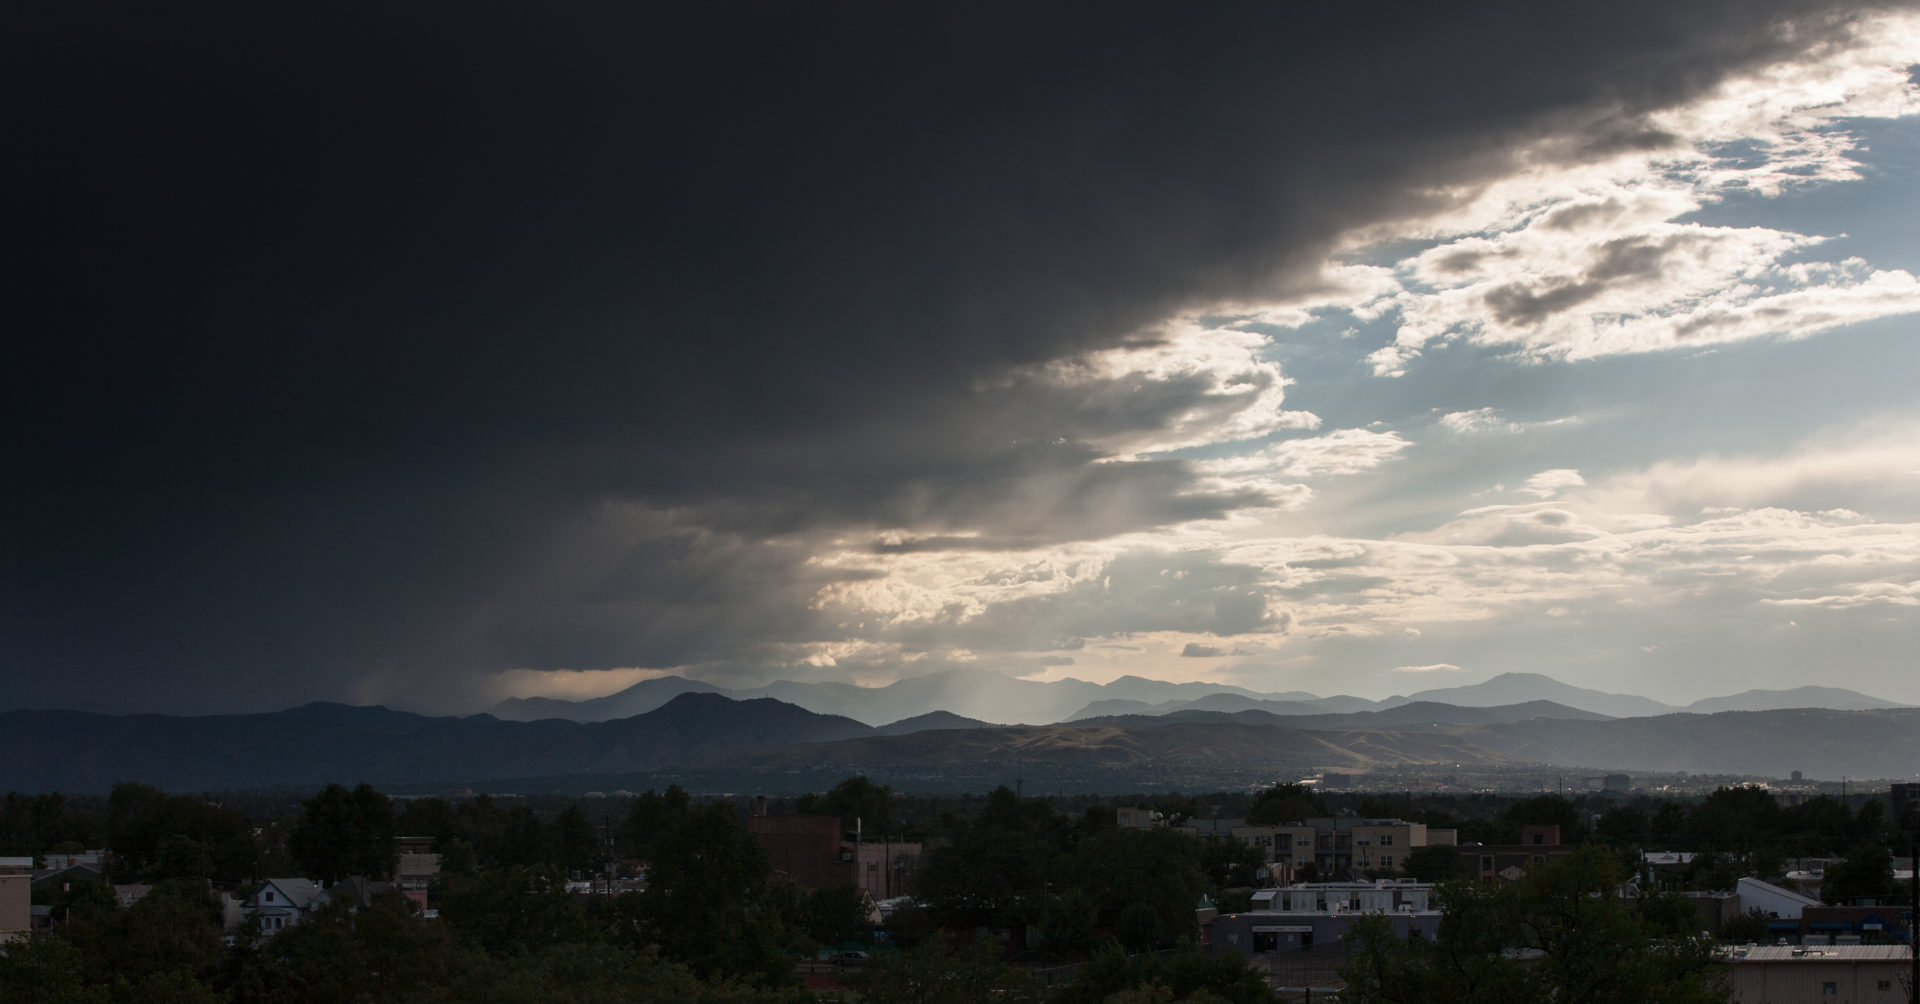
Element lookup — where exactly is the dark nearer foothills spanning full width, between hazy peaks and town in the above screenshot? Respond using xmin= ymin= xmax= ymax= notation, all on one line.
xmin=0 ymin=678 xmax=1920 ymax=793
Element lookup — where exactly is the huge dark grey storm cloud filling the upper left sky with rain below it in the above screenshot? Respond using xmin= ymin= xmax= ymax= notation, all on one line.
xmin=0 ymin=0 xmax=1889 ymax=708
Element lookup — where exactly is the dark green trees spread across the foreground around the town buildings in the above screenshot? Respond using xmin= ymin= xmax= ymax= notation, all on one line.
xmin=0 ymin=777 xmax=1908 ymax=1002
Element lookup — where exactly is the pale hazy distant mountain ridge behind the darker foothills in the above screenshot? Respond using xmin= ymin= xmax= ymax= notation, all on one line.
xmin=490 ymin=670 xmax=1901 ymax=726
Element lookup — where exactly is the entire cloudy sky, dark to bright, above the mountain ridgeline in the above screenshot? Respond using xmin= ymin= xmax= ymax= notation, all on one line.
xmin=11 ymin=0 xmax=1920 ymax=714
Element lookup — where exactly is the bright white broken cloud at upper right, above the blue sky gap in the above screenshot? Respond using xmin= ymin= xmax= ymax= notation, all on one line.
xmin=1236 ymin=12 xmax=1920 ymax=376
